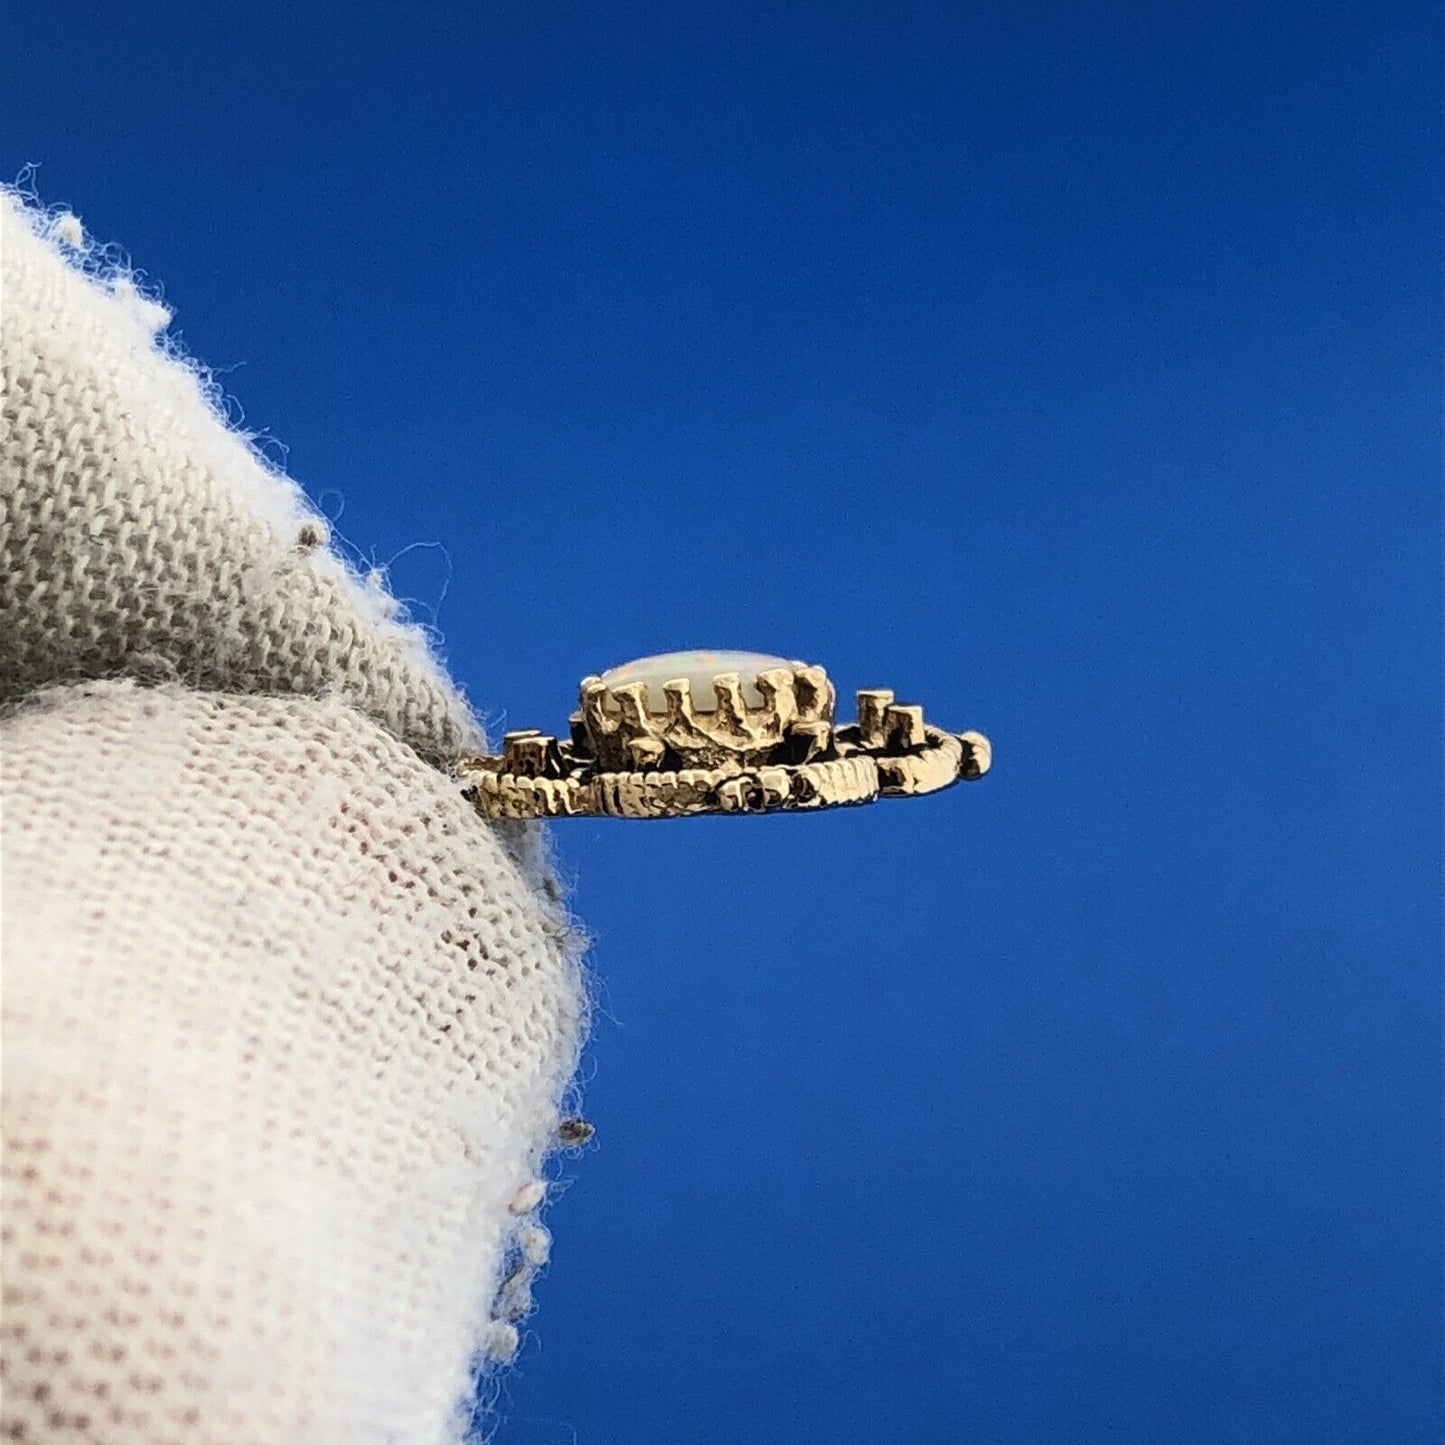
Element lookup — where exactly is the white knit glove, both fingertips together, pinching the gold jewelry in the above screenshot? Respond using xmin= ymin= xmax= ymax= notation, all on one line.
xmin=0 ymin=201 xmax=582 ymax=1445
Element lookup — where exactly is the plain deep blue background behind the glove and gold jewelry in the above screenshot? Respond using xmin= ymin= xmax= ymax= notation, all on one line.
xmin=8 ymin=3 xmax=1442 ymax=1445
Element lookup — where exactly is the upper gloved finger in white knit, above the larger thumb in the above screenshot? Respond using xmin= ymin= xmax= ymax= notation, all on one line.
xmin=0 ymin=194 xmax=481 ymax=780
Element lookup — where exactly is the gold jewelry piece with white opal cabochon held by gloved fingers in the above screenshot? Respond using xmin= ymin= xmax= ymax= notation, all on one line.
xmin=458 ymin=653 xmax=991 ymax=818
